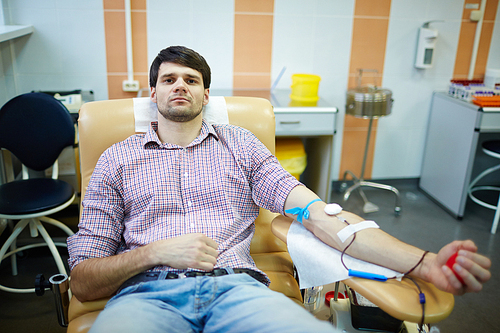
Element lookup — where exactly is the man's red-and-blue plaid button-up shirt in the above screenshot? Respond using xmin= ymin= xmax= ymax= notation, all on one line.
xmin=68 ymin=121 xmax=299 ymax=280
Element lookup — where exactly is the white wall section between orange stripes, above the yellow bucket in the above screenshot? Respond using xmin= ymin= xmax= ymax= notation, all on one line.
xmin=272 ymin=0 xmax=354 ymax=179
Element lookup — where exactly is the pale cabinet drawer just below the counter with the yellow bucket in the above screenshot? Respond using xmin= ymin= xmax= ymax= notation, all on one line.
xmin=274 ymin=112 xmax=335 ymax=136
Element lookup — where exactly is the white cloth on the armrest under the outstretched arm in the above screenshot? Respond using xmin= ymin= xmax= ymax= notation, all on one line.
xmin=287 ymin=221 xmax=399 ymax=289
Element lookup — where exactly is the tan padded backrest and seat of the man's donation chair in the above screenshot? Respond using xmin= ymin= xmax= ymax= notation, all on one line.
xmin=59 ymin=97 xmax=302 ymax=332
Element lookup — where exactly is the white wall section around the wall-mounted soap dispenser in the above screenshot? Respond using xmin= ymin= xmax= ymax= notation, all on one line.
xmin=372 ymin=0 xmax=463 ymax=179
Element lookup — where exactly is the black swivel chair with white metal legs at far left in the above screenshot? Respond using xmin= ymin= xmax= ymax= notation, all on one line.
xmin=0 ymin=93 xmax=75 ymax=293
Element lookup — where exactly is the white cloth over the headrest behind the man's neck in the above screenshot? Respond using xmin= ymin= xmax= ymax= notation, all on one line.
xmin=134 ymin=96 xmax=229 ymax=133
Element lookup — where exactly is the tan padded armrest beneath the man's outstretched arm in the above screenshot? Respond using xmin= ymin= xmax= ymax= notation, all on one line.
xmin=271 ymin=215 xmax=455 ymax=323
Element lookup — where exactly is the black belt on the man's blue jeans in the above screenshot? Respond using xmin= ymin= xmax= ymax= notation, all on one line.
xmin=117 ymin=268 xmax=267 ymax=293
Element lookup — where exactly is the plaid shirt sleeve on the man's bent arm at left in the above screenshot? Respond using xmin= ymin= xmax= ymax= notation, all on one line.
xmin=68 ymin=152 xmax=124 ymax=270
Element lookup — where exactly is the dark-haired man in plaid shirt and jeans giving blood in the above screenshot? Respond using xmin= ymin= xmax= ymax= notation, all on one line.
xmin=68 ymin=47 xmax=490 ymax=332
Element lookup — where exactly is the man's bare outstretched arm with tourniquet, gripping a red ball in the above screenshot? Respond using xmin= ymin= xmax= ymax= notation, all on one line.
xmin=284 ymin=186 xmax=491 ymax=294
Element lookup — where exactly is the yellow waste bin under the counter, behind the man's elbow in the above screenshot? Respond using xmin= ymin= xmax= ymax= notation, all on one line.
xmin=276 ymin=138 xmax=307 ymax=179
